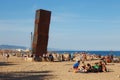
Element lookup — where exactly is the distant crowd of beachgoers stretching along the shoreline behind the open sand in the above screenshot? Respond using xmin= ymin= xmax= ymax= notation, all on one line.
xmin=0 ymin=50 xmax=120 ymax=63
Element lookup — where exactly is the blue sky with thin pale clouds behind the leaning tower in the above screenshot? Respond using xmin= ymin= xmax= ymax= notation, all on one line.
xmin=0 ymin=0 xmax=120 ymax=50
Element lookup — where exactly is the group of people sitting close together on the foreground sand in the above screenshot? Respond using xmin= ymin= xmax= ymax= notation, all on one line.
xmin=73 ymin=61 xmax=107 ymax=73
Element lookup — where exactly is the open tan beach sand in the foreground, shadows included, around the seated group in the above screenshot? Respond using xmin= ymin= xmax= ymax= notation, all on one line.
xmin=0 ymin=56 xmax=120 ymax=80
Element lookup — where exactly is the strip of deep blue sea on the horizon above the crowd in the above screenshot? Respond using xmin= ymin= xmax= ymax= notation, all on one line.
xmin=52 ymin=51 xmax=120 ymax=56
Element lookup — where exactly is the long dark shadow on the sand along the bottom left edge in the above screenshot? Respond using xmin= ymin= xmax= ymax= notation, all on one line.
xmin=0 ymin=71 xmax=55 ymax=80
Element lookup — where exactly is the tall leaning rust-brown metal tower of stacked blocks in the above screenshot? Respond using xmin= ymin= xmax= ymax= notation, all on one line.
xmin=32 ymin=9 xmax=51 ymax=57
